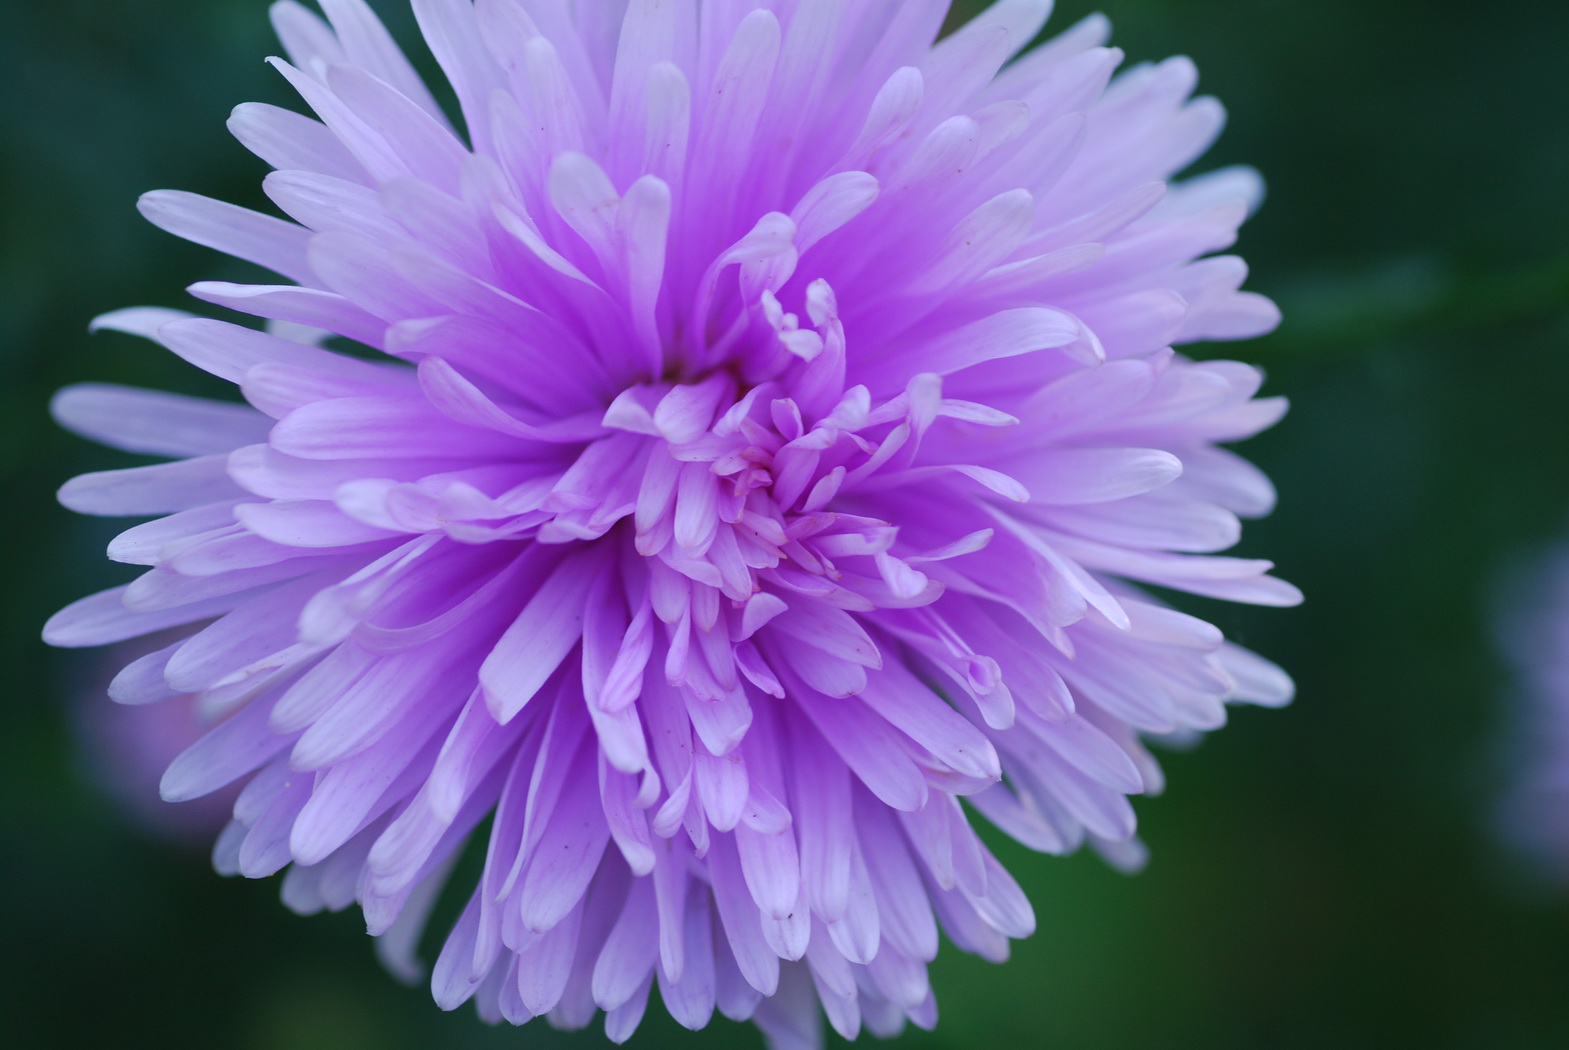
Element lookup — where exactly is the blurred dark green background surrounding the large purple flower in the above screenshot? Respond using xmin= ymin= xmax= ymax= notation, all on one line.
xmin=0 ymin=0 xmax=1569 ymax=1050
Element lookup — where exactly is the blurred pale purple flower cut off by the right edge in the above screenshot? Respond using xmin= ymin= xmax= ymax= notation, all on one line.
xmin=1498 ymin=545 xmax=1569 ymax=884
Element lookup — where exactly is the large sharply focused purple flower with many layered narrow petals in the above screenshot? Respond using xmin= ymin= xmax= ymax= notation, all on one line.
xmin=47 ymin=0 xmax=1299 ymax=1047
